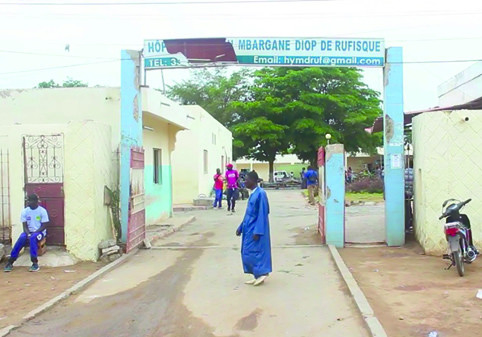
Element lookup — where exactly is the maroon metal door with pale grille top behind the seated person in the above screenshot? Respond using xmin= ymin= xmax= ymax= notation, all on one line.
xmin=23 ymin=134 xmax=65 ymax=245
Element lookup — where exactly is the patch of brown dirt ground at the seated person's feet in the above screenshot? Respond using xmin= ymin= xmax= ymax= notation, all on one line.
xmin=0 ymin=262 xmax=104 ymax=329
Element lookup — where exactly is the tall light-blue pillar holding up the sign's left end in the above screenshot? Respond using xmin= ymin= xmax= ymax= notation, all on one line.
xmin=119 ymin=50 xmax=142 ymax=242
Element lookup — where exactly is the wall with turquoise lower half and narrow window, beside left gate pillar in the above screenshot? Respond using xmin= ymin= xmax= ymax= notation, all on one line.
xmin=143 ymin=113 xmax=172 ymax=225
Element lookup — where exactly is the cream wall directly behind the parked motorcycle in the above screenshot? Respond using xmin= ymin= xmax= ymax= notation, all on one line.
xmin=413 ymin=111 xmax=482 ymax=255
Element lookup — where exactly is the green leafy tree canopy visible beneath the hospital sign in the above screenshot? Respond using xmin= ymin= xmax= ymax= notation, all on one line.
xmin=169 ymin=67 xmax=382 ymax=180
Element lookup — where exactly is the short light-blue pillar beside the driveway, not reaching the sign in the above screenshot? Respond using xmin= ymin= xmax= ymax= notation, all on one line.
xmin=325 ymin=144 xmax=345 ymax=248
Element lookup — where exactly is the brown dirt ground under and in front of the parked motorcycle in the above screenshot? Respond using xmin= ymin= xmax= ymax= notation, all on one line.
xmin=340 ymin=236 xmax=482 ymax=337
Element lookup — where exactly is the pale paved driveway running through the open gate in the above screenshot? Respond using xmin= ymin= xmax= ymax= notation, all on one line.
xmin=10 ymin=191 xmax=368 ymax=337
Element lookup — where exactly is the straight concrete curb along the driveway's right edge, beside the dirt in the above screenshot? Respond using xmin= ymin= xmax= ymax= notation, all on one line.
xmin=328 ymin=245 xmax=388 ymax=337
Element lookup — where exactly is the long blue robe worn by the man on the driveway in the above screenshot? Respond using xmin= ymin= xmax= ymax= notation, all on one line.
xmin=238 ymin=187 xmax=272 ymax=278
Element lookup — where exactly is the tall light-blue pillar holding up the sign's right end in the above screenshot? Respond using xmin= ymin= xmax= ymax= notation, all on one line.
xmin=383 ymin=47 xmax=405 ymax=246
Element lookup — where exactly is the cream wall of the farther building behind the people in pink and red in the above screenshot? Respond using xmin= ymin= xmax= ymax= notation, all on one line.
xmin=172 ymin=105 xmax=233 ymax=204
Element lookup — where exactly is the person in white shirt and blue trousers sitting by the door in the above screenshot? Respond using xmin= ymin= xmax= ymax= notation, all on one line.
xmin=4 ymin=194 xmax=49 ymax=272
